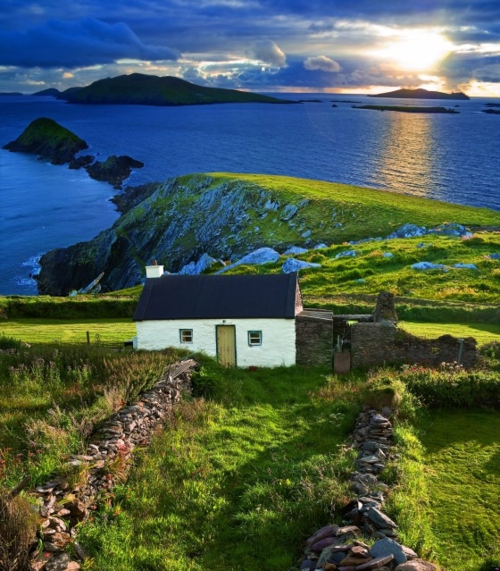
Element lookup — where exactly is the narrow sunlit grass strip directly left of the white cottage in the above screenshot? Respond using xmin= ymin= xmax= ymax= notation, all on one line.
xmin=0 ymin=318 xmax=136 ymax=344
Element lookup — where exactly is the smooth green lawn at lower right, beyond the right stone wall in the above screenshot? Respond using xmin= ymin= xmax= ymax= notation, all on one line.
xmin=414 ymin=411 xmax=500 ymax=571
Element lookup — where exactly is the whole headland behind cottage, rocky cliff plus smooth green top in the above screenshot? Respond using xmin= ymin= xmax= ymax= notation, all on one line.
xmin=38 ymin=173 xmax=500 ymax=295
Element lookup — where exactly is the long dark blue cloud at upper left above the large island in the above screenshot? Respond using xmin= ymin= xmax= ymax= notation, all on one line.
xmin=0 ymin=18 xmax=180 ymax=68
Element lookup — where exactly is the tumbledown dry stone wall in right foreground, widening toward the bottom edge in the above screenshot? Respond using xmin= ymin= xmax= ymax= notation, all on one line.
xmin=300 ymin=408 xmax=436 ymax=571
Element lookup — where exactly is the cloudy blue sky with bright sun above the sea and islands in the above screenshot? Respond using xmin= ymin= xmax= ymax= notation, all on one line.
xmin=0 ymin=0 xmax=500 ymax=97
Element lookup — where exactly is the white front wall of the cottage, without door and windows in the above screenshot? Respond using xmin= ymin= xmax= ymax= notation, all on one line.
xmin=136 ymin=319 xmax=295 ymax=367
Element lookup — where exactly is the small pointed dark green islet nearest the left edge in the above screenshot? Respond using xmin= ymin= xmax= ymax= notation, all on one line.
xmin=3 ymin=117 xmax=88 ymax=165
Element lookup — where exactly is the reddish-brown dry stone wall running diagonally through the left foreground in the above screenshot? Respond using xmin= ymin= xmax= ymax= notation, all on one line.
xmin=26 ymin=359 xmax=197 ymax=571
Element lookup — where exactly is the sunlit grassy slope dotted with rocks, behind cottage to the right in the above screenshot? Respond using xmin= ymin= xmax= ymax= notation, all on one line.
xmin=218 ymin=233 xmax=500 ymax=308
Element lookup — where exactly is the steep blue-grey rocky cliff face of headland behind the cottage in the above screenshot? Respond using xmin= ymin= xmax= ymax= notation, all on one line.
xmin=38 ymin=175 xmax=342 ymax=295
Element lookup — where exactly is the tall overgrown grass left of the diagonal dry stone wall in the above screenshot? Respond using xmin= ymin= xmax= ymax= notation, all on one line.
xmin=0 ymin=337 xmax=180 ymax=491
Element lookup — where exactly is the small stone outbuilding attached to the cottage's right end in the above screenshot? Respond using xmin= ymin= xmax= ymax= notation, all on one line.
xmin=295 ymin=309 xmax=334 ymax=367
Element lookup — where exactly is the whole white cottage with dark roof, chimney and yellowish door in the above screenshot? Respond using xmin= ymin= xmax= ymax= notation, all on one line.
xmin=134 ymin=266 xmax=303 ymax=367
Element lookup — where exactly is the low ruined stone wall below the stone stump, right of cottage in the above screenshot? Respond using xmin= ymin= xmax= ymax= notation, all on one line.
xmin=351 ymin=322 xmax=477 ymax=368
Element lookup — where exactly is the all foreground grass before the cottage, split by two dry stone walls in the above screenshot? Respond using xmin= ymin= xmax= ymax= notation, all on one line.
xmin=0 ymin=330 xmax=500 ymax=571
